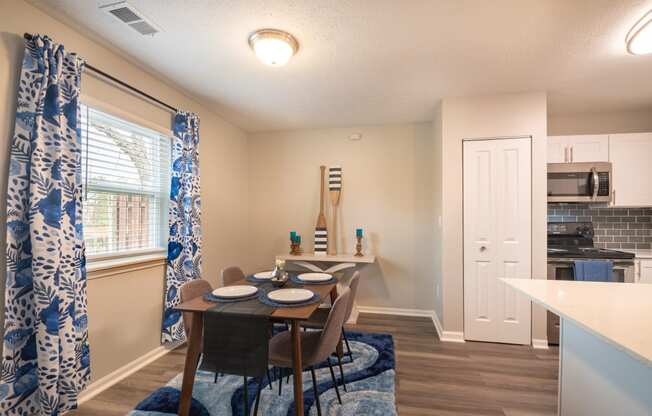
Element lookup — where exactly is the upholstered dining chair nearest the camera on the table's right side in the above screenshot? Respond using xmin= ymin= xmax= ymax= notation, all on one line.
xmin=269 ymin=288 xmax=351 ymax=416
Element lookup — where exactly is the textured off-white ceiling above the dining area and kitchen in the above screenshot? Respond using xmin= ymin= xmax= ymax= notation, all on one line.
xmin=33 ymin=0 xmax=652 ymax=131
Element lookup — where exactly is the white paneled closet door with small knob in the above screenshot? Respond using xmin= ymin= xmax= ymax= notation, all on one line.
xmin=464 ymin=138 xmax=532 ymax=344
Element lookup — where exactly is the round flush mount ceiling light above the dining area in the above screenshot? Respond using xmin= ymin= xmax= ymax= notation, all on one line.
xmin=249 ymin=29 xmax=299 ymax=66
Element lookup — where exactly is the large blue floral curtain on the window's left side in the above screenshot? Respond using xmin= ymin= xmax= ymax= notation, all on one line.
xmin=0 ymin=36 xmax=90 ymax=415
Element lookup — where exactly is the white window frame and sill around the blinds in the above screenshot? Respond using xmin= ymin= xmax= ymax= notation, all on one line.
xmin=80 ymin=98 xmax=174 ymax=264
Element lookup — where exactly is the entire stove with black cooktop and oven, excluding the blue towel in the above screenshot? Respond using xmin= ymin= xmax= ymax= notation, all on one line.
xmin=547 ymin=222 xmax=634 ymax=344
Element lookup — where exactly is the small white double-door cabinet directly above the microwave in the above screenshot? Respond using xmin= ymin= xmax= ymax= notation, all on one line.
xmin=548 ymin=134 xmax=609 ymax=163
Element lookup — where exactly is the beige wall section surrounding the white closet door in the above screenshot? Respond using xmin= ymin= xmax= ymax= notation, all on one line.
xmin=440 ymin=93 xmax=547 ymax=338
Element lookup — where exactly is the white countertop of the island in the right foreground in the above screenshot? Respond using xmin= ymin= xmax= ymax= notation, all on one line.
xmin=502 ymin=279 xmax=652 ymax=367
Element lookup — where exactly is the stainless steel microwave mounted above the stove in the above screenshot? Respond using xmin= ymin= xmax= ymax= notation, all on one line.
xmin=548 ymin=162 xmax=612 ymax=203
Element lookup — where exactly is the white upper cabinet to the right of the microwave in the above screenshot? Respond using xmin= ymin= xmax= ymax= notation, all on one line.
xmin=609 ymin=133 xmax=652 ymax=207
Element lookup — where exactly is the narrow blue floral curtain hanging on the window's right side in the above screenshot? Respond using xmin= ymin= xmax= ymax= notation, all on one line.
xmin=162 ymin=112 xmax=201 ymax=343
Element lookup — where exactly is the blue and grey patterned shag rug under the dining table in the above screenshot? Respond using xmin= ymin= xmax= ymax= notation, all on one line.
xmin=129 ymin=332 xmax=397 ymax=416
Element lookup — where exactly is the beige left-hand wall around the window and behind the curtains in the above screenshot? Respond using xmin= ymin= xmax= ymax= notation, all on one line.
xmin=0 ymin=0 xmax=248 ymax=380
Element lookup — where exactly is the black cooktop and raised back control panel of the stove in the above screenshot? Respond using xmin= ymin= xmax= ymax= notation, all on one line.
xmin=548 ymin=222 xmax=634 ymax=260
